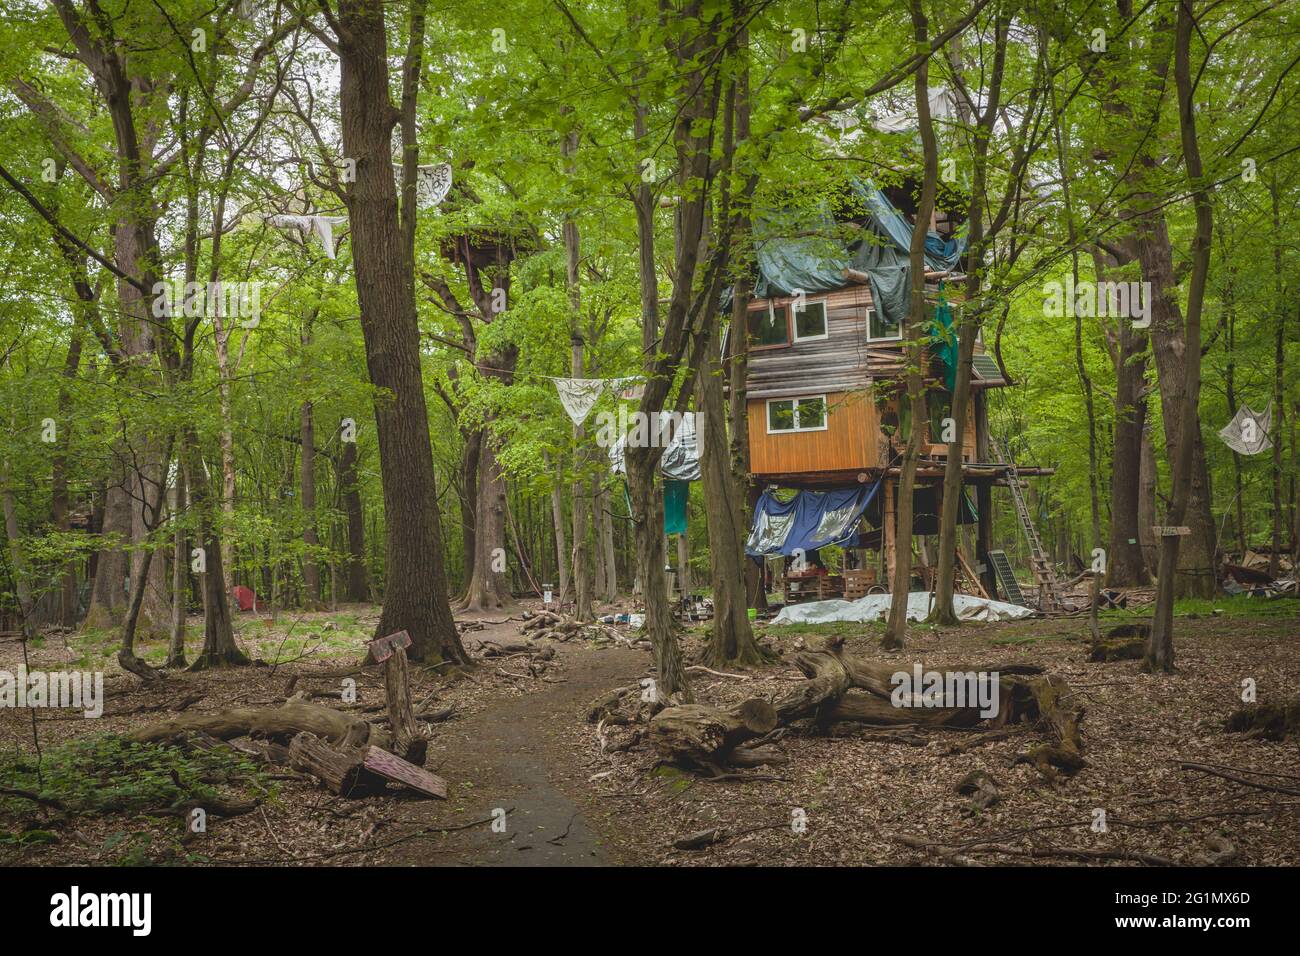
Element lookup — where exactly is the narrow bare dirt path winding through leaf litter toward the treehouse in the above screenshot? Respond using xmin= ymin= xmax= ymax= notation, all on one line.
xmin=389 ymin=631 xmax=649 ymax=866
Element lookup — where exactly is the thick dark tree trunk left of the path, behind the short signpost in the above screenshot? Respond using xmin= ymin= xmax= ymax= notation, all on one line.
xmin=338 ymin=0 xmax=469 ymax=663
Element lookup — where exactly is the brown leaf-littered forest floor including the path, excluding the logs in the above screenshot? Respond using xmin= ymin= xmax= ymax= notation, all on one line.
xmin=0 ymin=598 xmax=1300 ymax=866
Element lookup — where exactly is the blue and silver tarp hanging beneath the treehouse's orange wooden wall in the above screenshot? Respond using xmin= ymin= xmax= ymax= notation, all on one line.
xmin=745 ymin=477 xmax=883 ymax=557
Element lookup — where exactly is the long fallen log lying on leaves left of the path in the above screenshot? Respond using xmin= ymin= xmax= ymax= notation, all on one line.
xmin=127 ymin=698 xmax=389 ymax=749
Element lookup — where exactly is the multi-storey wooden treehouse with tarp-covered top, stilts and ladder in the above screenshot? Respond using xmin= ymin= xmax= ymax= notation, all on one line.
xmin=724 ymin=182 xmax=1062 ymax=611
